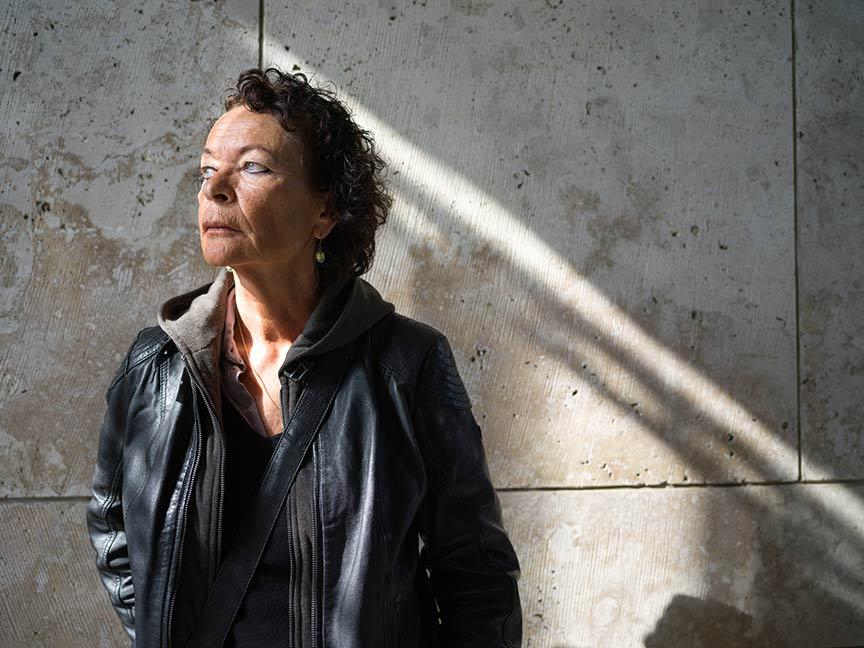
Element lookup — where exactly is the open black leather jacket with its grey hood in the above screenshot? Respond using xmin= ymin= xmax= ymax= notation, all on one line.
xmin=86 ymin=270 xmax=522 ymax=648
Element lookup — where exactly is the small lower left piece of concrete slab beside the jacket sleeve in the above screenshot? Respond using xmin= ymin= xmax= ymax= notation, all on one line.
xmin=0 ymin=502 xmax=129 ymax=648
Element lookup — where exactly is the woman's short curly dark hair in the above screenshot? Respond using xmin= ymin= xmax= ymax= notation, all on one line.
xmin=223 ymin=67 xmax=393 ymax=277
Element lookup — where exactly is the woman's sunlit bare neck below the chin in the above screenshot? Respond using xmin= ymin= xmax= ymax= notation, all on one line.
xmin=234 ymin=266 xmax=322 ymax=347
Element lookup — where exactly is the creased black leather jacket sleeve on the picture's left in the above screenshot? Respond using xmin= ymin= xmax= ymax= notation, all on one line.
xmin=86 ymin=343 xmax=135 ymax=646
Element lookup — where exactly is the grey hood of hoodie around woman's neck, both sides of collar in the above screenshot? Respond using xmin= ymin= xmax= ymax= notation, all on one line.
xmin=158 ymin=268 xmax=394 ymax=412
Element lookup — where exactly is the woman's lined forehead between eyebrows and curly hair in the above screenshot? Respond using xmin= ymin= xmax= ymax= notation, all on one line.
xmin=204 ymin=106 xmax=299 ymax=159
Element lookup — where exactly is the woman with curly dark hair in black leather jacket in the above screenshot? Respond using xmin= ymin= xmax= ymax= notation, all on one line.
xmin=87 ymin=68 xmax=521 ymax=648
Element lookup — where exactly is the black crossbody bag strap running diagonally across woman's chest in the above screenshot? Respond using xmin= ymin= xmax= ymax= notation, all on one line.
xmin=186 ymin=340 xmax=356 ymax=648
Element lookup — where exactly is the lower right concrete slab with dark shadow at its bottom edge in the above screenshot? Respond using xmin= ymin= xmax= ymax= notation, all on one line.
xmin=502 ymin=484 xmax=864 ymax=648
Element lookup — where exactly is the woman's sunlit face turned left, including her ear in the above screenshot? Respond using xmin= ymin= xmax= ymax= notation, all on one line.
xmin=198 ymin=106 xmax=335 ymax=272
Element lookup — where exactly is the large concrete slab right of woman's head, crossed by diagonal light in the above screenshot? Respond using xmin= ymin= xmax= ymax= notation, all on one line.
xmin=264 ymin=0 xmax=798 ymax=487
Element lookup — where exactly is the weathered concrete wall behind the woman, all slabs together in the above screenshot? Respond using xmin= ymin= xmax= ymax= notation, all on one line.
xmin=0 ymin=0 xmax=864 ymax=648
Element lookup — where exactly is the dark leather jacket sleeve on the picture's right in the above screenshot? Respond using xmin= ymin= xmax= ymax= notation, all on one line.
xmin=413 ymin=333 xmax=522 ymax=648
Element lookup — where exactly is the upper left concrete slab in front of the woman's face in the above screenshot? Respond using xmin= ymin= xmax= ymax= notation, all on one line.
xmin=0 ymin=1 xmax=258 ymax=496
